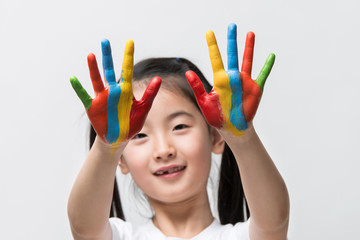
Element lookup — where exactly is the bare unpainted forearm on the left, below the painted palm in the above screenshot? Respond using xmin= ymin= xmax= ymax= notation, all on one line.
xmin=68 ymin=137 xmax=126 ymax=237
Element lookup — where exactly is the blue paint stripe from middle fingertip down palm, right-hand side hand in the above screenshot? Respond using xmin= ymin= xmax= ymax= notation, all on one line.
xmin=227 ymin=24 xmax=248 ymax=130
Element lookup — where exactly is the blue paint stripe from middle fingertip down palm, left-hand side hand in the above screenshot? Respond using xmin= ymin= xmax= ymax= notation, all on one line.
xmin=101 ymin=39 xmax=121 ymax=143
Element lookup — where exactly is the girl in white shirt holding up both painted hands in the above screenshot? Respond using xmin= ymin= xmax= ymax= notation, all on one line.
xmin=68 ymin=24 xmax=289 ymax=240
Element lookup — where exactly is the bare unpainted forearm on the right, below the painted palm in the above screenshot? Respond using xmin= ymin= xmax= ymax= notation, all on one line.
xmin=222 ymin=125 xmax=289 ymax=236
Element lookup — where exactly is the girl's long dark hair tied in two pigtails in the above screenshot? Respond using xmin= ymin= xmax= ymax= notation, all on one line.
xmin=90 ymin=58 xmax=250 ymax=224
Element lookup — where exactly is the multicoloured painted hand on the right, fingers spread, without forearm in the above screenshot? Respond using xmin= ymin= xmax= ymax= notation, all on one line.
xmin=186 ymin=24 xmax=275 ymax=136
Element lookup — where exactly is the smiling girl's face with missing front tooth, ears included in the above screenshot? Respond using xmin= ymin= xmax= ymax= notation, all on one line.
xmin=120 ymin=81 xmax=224 ymax=203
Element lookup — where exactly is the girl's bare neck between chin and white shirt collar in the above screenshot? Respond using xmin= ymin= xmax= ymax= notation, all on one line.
xmin=149 ymin=189 xmax=214 ymax=238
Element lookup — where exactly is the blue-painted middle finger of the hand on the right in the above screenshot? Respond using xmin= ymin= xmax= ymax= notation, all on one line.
xmin=227 ymin=23 xmax=239 ymax=71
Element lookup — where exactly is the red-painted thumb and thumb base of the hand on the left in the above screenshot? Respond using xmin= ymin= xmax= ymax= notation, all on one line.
xmin=128 ymin=77 xmax=161 ymax=138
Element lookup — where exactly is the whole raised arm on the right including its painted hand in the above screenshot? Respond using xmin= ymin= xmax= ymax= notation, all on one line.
xmin=186 ymin=24 xmax=289 ymax=239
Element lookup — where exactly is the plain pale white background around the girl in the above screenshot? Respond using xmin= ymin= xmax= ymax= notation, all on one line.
xmin=0 ymin=0 xmax=360 ymax=240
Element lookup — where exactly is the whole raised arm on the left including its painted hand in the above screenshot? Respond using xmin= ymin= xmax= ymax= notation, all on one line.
xmin=68 ymin=40 xmax=161 ymax=239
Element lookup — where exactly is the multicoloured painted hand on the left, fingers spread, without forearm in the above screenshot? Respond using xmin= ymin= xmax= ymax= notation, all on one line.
xmin=70 ymin=40 xmax=161 ymax=145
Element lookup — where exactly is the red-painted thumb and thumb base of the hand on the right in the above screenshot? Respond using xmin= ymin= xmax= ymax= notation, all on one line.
xmin=185 ymin=71 xmax=224 ymax=129
